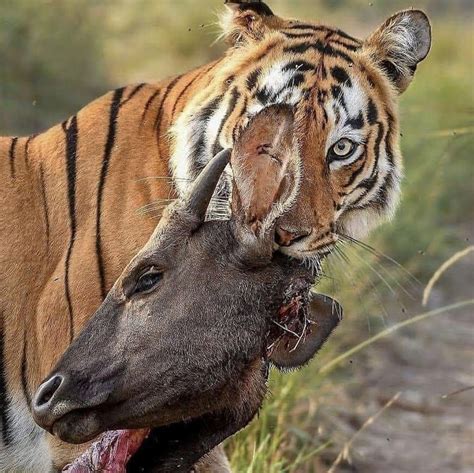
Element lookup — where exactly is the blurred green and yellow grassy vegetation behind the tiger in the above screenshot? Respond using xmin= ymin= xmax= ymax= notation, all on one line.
xmin=0 ymin=0 xmax=474 ymax=473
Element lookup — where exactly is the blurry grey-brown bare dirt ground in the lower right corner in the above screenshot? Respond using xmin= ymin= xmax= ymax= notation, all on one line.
xmin=336 ymin=253 xmax=474 ymax=473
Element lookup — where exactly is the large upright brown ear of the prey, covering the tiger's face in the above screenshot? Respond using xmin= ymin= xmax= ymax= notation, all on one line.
xmin=231 ymin=105 xmax=299 ymax=236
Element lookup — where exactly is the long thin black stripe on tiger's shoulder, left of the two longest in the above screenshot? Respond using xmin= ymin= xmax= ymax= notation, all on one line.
xmin=63 ymin=116 xmax=78 ymax=341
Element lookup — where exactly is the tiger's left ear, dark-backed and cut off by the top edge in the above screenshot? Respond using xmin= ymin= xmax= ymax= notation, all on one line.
xmin=221 ymin=0 xmax=275 ymax=46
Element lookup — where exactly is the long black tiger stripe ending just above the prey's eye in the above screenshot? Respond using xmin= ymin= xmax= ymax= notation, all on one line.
xmin=95 ymin=88 xmax=123 ymax=299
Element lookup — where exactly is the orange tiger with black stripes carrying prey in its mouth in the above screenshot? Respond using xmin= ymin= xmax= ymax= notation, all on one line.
xmin=0 ymin=2 xmax=431 ymax=472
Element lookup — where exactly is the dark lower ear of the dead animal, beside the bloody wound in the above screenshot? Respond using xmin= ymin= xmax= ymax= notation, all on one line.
xmin=269 ymin=292 xmax=343 ymax=369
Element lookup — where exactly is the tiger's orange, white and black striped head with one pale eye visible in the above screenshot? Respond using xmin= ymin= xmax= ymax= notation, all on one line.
xmin=171 ymin=2 xmax=431 ymax=260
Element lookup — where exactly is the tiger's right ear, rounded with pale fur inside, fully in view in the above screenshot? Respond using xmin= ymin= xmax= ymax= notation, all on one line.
xmin=365 ymin=10 xmax=431 ymax=93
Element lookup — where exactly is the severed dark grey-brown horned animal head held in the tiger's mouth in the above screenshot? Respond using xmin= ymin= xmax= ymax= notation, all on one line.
xmin=33 ymin=106 xmax=340 ymax=472
